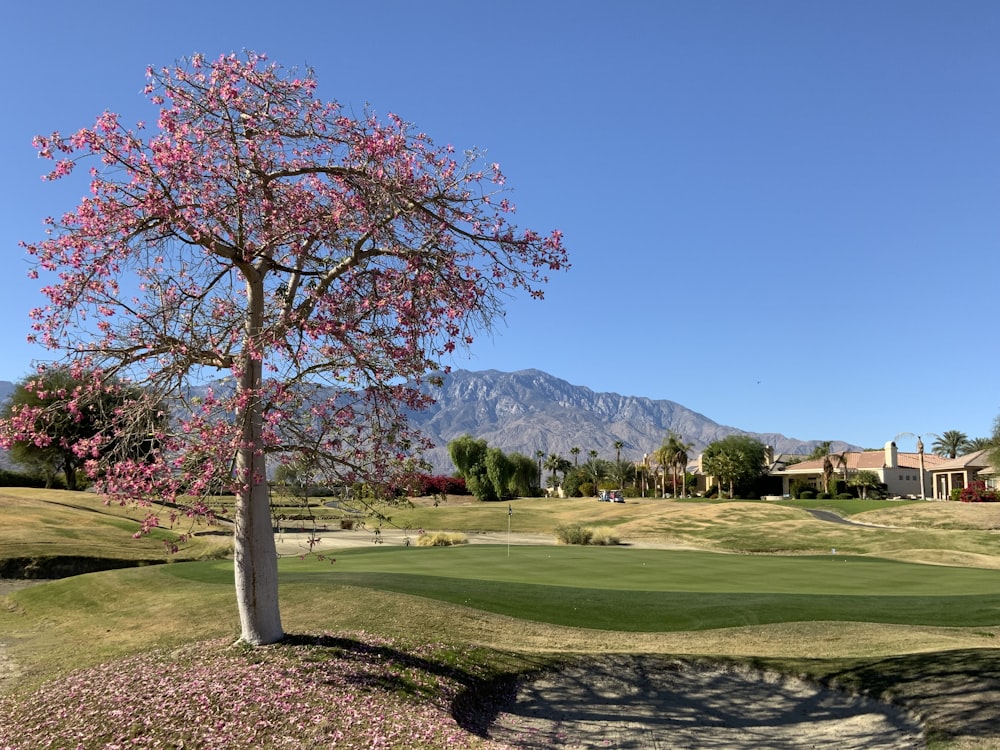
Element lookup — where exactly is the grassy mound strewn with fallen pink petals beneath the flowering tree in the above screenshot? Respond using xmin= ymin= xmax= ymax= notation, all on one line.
xmin=0 ymin=633 xmax=516 ymax=750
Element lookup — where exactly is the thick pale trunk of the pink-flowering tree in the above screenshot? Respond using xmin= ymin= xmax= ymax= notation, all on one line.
xmin=233 ymin=281 xmax=285 ymax=646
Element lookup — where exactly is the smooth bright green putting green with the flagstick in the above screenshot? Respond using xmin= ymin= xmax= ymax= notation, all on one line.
xmin=170 ymin=545 xmax=1000 ymax=632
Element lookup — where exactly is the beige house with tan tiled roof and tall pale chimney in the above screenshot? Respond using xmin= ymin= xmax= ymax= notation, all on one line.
xmin=769 ymin=440 xmax=948 ymax=499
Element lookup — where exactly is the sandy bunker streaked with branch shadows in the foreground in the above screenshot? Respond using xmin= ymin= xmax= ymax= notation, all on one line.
xmin=490 ymin=655 xmax=926 ymax=750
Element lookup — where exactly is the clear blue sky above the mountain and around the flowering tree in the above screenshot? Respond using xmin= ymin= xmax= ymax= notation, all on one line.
xmin=0 ymin=0 xmax=1000 ymax=450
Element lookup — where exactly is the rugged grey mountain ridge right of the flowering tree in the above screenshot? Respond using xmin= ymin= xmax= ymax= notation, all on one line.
xmin=411 ymin=370 xmax=849 ymax=473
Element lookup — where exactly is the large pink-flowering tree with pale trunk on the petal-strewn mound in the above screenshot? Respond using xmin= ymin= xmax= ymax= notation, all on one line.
xmin=2 ymin=53 xmax=566 ymax=644
